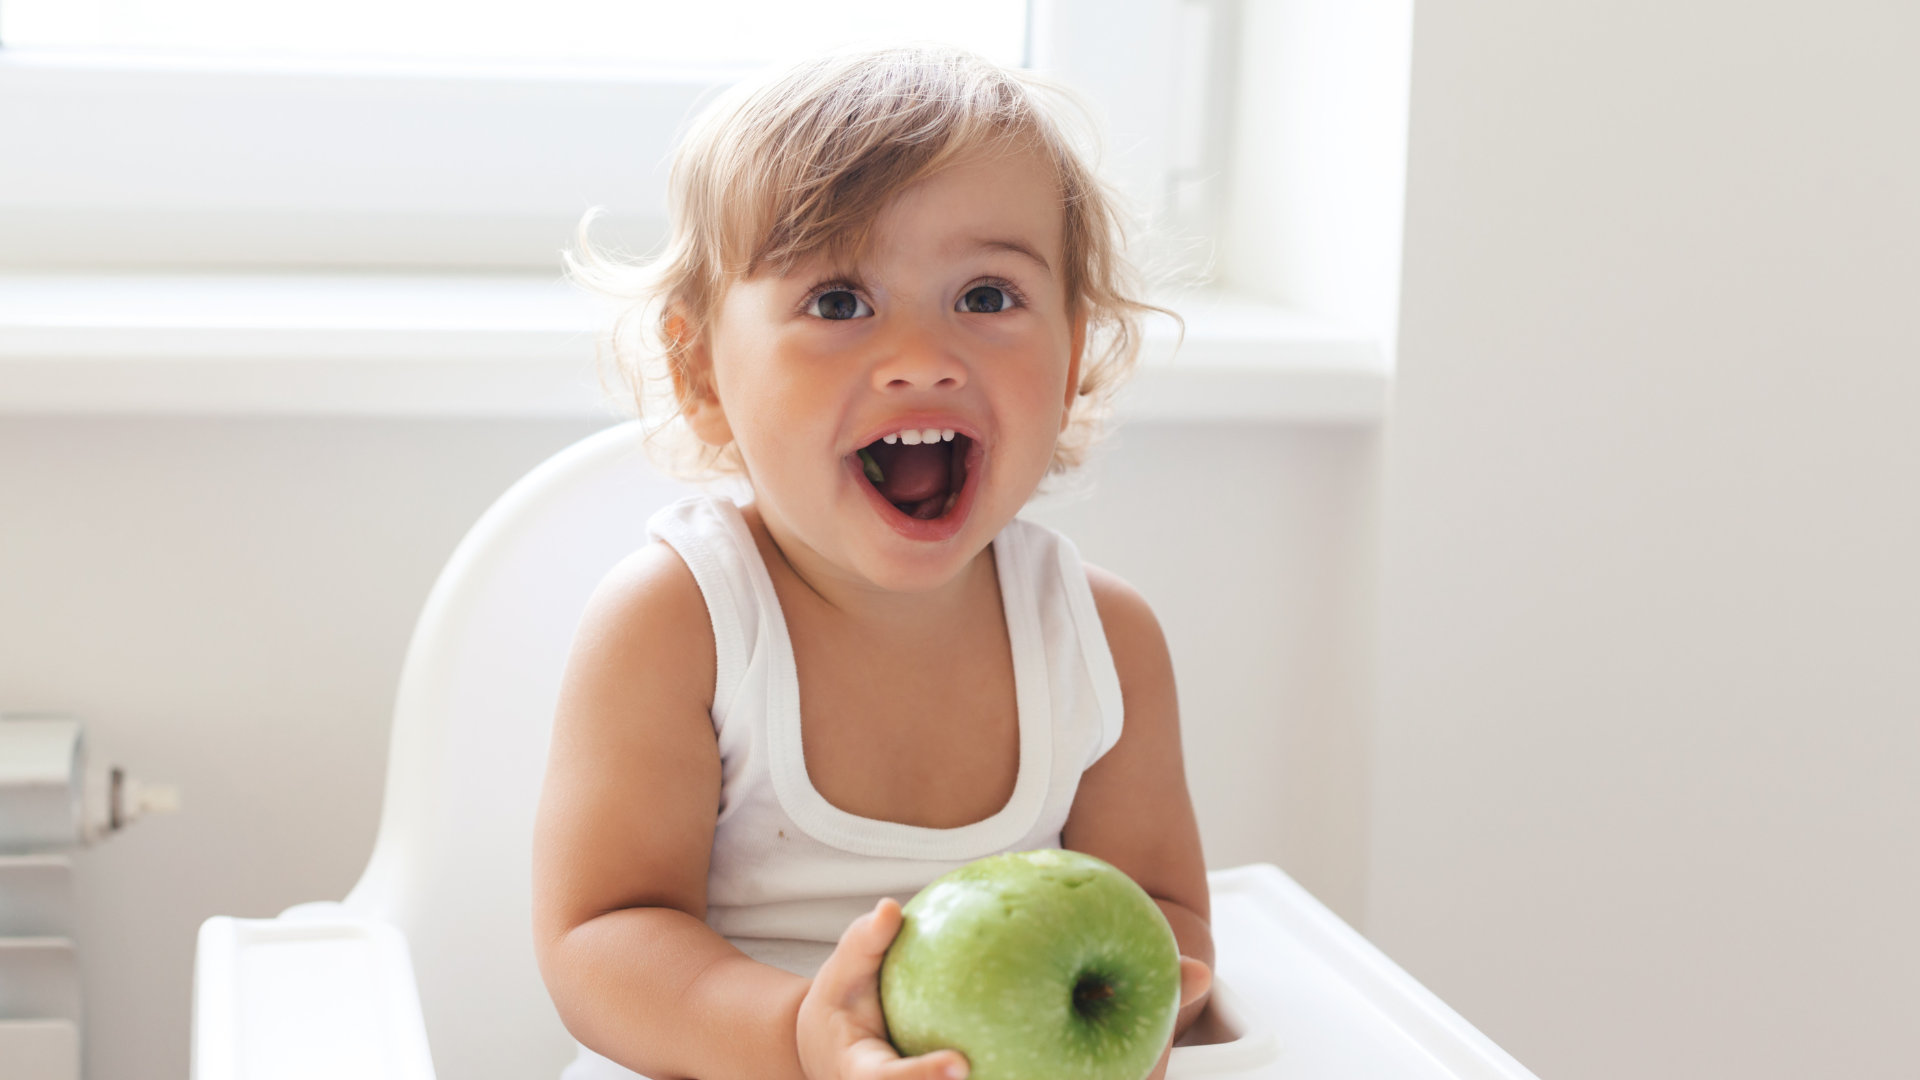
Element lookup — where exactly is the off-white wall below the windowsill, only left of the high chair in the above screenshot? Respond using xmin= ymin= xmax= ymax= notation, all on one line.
xmin=0 ymin=419 xmax=606 ymax=1080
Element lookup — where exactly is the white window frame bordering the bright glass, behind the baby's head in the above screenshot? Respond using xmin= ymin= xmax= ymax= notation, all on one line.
xmin=0 ymin=0 xmax=1231 ymax=271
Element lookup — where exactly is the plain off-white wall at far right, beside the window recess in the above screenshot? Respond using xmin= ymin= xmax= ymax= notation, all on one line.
xmin=1367 ymin=0 xmax=1920 ymax=1080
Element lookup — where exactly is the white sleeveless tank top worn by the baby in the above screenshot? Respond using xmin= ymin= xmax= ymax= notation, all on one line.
xmin=564 ymin=496 xmax=1121 ymax=1080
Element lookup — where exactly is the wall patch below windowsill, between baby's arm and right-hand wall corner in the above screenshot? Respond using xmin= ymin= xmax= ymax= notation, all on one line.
xmin=1029 ymin=425 xmax=1379 ymax=922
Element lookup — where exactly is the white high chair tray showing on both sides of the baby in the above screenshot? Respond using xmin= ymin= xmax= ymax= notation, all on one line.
xmin=192 ymin=865 xmax=1534 ymax=1080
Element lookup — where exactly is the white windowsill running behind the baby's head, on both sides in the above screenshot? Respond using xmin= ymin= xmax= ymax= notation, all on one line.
xmin=0 ymin=273 xmax=1390 ymax=423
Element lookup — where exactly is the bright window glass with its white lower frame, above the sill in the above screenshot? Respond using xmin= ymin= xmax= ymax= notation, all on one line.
xmin=0 ymin=0 xmax=1027 ymax=271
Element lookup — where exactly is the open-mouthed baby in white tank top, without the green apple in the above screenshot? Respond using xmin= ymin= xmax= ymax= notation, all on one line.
xmin=534 ymin=48 xmax=1213 ymax=1080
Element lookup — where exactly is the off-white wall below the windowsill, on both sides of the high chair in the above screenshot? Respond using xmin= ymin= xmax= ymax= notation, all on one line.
xmin=0 ymin=409 xmax=1377 ymax=1080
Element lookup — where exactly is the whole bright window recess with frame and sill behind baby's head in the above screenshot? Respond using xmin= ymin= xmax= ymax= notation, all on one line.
xmin=0 ymin=0 xmax=1411 ymax=419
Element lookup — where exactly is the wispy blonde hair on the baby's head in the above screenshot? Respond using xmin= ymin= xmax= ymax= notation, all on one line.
xmin=566 ymin=46 xmax=1158 ymax=477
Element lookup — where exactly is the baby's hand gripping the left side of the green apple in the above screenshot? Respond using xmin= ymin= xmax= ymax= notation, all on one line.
xmin=795 ymin=899 xmax=967 ymax=1080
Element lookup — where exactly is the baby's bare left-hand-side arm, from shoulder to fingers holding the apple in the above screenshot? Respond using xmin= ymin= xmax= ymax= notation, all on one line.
xmin=534 ymin=544 xmax=964 ymax=1080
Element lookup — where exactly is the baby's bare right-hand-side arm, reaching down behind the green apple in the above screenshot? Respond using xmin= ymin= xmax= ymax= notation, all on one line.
xmin=1060 ymin=567 xmax=1213 ymax=1065
